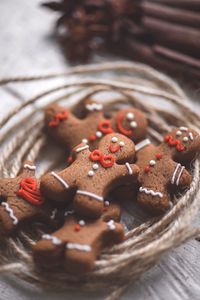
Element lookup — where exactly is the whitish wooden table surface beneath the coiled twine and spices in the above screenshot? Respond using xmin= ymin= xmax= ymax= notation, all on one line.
xmin=0 ymin=0 xmax=200 ymax=300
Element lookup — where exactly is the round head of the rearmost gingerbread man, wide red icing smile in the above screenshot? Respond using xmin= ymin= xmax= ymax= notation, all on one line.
xmin=112 ymin=108 xmax=148 ymax=143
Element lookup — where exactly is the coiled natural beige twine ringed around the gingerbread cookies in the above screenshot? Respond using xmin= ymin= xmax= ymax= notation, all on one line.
xmin=0 ymin=62 xmax=200 ymax=300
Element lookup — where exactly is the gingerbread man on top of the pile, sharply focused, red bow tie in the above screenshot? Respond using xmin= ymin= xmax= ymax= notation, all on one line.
xmin=41 ymin=133 xmax=139 ymax=218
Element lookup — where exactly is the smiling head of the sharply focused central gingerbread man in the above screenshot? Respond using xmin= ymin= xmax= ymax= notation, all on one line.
xmin=98 ymin=133 xmax=135 ymax=163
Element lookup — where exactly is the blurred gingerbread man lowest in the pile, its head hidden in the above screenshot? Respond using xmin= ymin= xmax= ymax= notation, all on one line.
xmin=33 ymin=205 xmax=124 ymax=274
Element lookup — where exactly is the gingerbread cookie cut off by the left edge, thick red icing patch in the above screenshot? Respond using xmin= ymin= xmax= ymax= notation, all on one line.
xmin=0 ymin=161 xmax=50 ymax=235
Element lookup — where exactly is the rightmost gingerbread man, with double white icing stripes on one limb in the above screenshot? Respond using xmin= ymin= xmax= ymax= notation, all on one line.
xmin=136 ymin=127 xmax=200 ymax=213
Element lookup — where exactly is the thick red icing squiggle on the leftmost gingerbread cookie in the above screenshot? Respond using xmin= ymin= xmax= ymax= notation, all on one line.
xmin=17 ymin=177 xmax=44 ymax=205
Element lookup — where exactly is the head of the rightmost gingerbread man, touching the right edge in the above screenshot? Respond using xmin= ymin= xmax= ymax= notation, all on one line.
xmin=163 ymin=126 xmax=200 ymax=163
